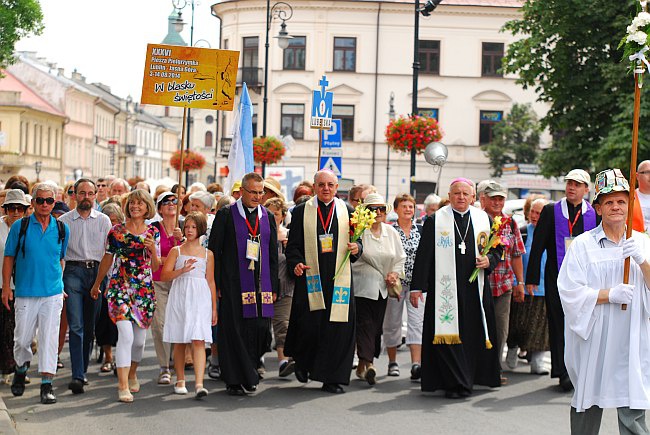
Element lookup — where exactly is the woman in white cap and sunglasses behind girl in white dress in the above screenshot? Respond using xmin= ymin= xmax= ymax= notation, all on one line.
xmin=151 ymin=192 xmax=183 ymax=385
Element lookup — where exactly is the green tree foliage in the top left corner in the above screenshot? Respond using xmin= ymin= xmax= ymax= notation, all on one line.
xmin=0 ymin=0 xmax=43 ymax=69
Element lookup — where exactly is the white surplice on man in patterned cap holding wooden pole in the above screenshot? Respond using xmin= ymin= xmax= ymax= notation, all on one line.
xmin=558 ymin=225 xmax=650 ymax=412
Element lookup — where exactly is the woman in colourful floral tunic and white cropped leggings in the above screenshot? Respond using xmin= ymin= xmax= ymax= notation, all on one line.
xmin=91 ymin=190 xmax=160 ymax=402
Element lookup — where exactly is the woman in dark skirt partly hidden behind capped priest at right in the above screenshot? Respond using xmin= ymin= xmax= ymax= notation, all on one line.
xmin=506 ymin=198 xmax=550 ymax=375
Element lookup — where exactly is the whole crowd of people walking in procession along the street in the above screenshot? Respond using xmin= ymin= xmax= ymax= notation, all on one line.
xmin=0 ymin=166 xmax=650 ymax=433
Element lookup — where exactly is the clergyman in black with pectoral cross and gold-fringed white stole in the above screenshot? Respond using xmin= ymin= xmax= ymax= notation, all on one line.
xmin=410 ymin=178 xmax=502 ymax=398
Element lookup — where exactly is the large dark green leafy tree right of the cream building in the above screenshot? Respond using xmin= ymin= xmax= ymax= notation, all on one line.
xmin=503 ymin=0 xmax=636 ymax=176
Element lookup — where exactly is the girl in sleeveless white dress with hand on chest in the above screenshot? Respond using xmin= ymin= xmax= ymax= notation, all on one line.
xmin=160 ymin=212 xmax=217 ymax=398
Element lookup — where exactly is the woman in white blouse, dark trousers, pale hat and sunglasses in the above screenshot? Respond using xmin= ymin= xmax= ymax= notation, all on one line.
xmin=352 ymin=193 xmax=406 ymax=385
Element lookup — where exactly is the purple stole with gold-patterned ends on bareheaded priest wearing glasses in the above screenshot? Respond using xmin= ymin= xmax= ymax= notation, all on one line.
xmin=230 ymin=201 xmax=273 ymax=319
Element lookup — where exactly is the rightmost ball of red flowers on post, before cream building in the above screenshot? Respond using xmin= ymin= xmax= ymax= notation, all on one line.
xmin=386 ymin=116 xmax=442 ymax=154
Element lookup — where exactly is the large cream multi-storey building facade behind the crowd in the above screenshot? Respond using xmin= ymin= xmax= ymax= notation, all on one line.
xmin=212 ymin=0 xmax=549 ymax=197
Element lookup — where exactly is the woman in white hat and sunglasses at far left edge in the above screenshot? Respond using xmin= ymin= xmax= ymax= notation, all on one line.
xmin=0 ymin=189 xmax=29 ymax=381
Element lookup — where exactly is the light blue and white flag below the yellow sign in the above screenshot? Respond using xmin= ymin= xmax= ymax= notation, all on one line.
xmin=224 ymin=83 xmax=255 ymax=192
